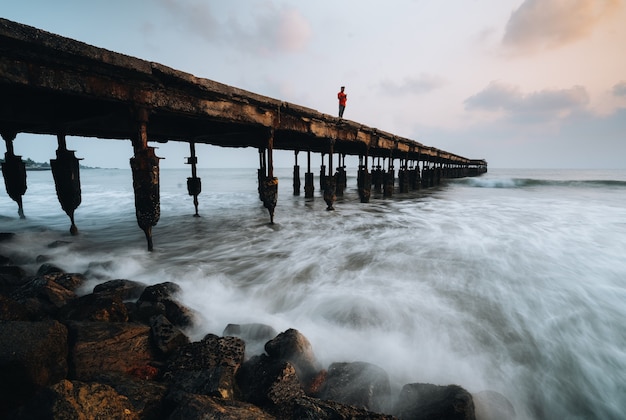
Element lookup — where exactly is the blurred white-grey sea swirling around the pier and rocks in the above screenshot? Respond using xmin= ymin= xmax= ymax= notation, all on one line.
xmin=0 ymin=168 xmax=626 ymax=420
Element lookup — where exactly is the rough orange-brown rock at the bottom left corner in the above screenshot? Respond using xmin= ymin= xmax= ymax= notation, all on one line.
xmin=9 ymin=380 xmax=140 ymax=420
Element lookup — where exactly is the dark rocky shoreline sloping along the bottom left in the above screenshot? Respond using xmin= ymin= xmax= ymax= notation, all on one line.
xmin=0 ymin=233 xmax=515 ymax=420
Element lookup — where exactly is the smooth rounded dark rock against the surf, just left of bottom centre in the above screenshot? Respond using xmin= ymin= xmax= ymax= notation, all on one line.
xmin=265 ymin=328 xmax=321 ymax=384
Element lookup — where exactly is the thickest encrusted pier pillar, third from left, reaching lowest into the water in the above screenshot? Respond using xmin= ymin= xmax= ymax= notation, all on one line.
xmin=130 ymin=109 xmax=161 ymax=251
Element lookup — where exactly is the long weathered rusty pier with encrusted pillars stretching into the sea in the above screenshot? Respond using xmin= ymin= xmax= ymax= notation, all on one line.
xmin=0 ymin=19 xmax=487 ymax=250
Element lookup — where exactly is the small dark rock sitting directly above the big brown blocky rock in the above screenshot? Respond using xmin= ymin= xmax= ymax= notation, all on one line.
xmin=58 ymin=294 xmax=128 ymax=322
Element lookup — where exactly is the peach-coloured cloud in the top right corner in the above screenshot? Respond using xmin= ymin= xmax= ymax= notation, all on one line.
xmin=502 ymin=0 xmax=622 ymax=52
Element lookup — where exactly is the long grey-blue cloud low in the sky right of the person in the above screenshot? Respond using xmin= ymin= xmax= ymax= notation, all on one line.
xmin=464 ymin=82 xmax=589 ymax=122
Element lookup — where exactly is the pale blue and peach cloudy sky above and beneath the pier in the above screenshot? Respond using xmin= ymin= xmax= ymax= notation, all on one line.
xmin=0 ymin=0 xmax=626 ymax=169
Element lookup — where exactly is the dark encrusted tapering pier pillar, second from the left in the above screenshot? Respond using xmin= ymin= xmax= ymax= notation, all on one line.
xmin=50 ymin=133 xmax=81 ymax=235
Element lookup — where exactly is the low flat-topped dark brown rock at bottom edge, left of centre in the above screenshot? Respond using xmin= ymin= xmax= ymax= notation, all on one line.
xmin=167 ymin=392 xmax=275 ymax=420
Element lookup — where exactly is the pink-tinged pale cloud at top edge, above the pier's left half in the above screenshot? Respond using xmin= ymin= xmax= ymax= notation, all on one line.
xmin=155 ymin=0 xmax=311 ymax=55
